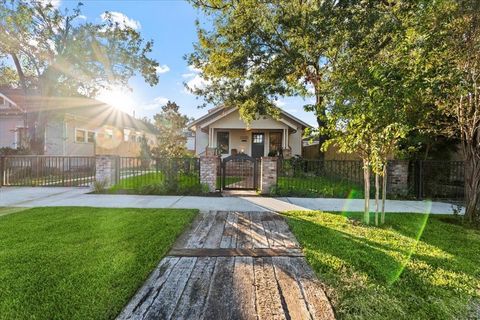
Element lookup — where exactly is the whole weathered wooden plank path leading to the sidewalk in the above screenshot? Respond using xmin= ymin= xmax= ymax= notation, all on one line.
xmin=117 ymin=211 xmax=335 ymax=320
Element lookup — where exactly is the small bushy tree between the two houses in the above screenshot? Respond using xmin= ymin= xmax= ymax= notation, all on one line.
xmin=153 ymin=101 xmax=189 ymax=157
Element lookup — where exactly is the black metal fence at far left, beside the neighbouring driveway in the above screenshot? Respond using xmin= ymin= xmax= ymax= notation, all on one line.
xmin=0 ymin=155 xmax=95 ymax=187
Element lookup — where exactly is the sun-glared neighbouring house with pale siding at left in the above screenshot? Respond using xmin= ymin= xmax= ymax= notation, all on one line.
xmin=0 ymin=89 xmax=156 ymax=157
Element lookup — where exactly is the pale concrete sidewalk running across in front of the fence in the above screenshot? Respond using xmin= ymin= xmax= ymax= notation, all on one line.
xmin=0 ymin=187 xmax=462 ymax=214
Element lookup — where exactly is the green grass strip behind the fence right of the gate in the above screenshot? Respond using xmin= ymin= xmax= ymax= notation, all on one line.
xmin=274 ymin=177 xmax=363 ymax=199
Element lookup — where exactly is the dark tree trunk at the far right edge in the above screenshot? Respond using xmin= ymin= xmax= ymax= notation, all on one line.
xmin=464 ymin=145 xmax=480 ymax=223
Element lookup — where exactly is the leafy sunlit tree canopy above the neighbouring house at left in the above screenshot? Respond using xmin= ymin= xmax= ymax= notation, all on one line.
xmin=0 ymin=0 xmax=158 ymax=96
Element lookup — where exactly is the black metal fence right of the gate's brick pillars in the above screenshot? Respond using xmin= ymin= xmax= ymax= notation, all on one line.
xmin=273 ymin=158 xmax=465 ymax=201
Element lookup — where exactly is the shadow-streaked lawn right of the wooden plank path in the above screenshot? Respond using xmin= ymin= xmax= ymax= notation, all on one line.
xmin=285 ymin=212 xmax=480 ymax=320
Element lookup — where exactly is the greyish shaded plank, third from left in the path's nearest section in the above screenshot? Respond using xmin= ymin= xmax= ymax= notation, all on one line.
xmin=168 ymin=257 xmax=216 ymax=319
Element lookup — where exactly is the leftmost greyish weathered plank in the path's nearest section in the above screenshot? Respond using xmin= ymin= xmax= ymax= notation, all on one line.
xmin=117 ymin=257 xmax=180 ymax=320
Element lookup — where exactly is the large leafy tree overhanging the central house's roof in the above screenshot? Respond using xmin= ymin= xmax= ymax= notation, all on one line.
xmin=188 ymin=0 xmax=357 ymax=155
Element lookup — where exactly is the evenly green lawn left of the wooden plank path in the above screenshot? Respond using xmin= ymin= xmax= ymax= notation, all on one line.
xmin=0 ymin=207 xmax=197 ymax=319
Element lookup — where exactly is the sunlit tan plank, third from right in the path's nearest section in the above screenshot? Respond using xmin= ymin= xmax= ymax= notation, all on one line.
xmin=253 ymin=258 xmax=287 ymax=320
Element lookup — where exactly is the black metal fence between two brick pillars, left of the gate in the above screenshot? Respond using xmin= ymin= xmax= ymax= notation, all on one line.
xmin=117 ymin=157 xmax=202 ymax=194
